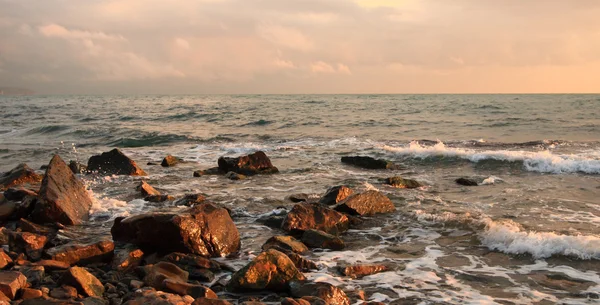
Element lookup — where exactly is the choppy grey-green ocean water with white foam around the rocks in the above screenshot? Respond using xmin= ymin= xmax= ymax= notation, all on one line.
xmin=0 ymin=95 xmax=600 ymax=304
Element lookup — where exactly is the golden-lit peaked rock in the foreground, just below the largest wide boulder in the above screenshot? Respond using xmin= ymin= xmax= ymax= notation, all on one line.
xmin=227 ymin=249 xmax=306 ymax=291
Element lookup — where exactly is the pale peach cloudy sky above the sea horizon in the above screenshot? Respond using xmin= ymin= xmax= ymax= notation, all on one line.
xmin=0 ymin=0 xmax=600 ymax=94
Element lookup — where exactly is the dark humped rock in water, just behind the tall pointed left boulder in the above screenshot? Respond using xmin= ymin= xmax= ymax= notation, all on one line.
xmin=88 ymin=148 xmax=146 ymax=176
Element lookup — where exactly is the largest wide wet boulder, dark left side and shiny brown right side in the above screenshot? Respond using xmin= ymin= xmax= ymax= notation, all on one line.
xmin=111 ymin=203 xmax=240 ymax=257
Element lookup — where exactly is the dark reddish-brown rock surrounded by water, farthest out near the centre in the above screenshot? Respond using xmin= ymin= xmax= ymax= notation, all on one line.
xmin=218 ymin=151 xmax=279 ymax=176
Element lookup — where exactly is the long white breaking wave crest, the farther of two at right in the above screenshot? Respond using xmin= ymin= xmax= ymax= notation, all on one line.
xmin=381 ymin=141 xmax=600 ymax=174
